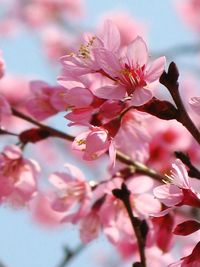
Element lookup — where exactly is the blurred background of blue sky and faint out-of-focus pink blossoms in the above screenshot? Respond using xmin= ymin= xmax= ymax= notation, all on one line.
xmin=0 ymin=0 xmax=200 ymax=267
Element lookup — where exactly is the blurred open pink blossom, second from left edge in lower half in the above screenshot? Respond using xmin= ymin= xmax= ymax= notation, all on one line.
xmin=49 ymin=164 xmax=91 ymax=223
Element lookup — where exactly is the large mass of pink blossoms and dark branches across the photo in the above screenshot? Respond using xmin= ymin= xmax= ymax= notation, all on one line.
xmin=0 ymin=0 xmax=200 ymax=267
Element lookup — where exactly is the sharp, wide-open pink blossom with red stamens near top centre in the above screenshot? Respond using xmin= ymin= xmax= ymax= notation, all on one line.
xmin=93 ymin=37 xmax=165 ymax=106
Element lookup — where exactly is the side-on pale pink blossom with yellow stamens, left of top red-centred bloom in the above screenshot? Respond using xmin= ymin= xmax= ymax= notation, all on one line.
xmin=59 ymin=21 xmax=120 ymax=80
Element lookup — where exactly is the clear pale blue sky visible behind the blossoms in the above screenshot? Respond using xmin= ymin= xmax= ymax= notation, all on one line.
xmin=0 ymin=0 xmax=196 ymax=267
